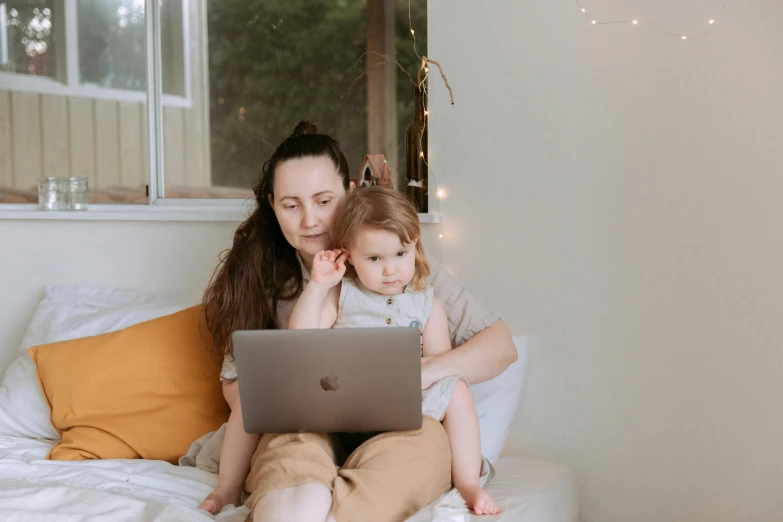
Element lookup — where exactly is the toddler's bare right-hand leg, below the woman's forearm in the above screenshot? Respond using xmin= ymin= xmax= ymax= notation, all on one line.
xmin=443 ymin=381 xmax=500 ymax=515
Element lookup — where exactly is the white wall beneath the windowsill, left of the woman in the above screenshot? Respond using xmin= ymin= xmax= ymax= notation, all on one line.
xmin=0 ymin=220 xmax=236 ymax=373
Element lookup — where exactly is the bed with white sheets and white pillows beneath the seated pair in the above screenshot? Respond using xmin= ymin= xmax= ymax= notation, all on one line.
xmin=0 ymin=287 xmax=578 ymax=522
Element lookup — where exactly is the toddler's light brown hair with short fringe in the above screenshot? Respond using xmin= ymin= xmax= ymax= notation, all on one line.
xmin=335 ymin=186 xmax=430 ymax=291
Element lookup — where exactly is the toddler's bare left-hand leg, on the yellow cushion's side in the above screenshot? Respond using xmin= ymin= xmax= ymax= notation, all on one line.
xmin=199 ymin=386 xmax=260 ymax=515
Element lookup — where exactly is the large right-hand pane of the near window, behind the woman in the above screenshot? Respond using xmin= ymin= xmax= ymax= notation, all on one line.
xmin=163 ymin=0 xmax=427 ymax=197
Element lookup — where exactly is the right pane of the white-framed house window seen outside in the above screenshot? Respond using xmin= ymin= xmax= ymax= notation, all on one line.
xmin=78 ymin=0 xmax=185 ymax=96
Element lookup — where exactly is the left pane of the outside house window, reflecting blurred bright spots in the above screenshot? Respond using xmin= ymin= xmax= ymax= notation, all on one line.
xmin=0 ymin=0 xmax=57 ymax=77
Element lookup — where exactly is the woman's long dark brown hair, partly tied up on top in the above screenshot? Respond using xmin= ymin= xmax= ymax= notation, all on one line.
xmin=201 ymin=121 xmax=350 ymax=355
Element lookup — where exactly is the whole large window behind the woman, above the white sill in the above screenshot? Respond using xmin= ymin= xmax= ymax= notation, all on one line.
xmin=0 ymin=0 xmax=427 ymax=209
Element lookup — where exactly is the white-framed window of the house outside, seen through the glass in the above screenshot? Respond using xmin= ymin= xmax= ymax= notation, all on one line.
xmin=0 ymin=0 xmax=188 ymax=100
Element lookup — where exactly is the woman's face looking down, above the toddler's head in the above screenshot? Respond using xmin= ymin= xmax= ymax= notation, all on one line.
xmin=270 ymin=156 xmax=346 ymax=260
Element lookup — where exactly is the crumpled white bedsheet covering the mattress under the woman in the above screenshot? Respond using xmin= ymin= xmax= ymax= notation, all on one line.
xmin=0 ymin=436 xmax=577 ymax=522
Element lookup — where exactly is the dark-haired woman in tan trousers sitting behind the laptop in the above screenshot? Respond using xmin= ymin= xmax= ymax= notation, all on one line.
xmin=202 ymin=122 xmax=516 ymax=522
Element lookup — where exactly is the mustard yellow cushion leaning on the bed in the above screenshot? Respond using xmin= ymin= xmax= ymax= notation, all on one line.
xmin=29 ymin=306 xmax=229 ymax=463
